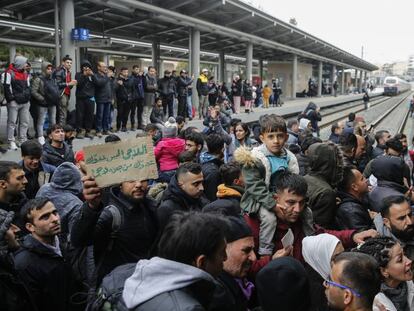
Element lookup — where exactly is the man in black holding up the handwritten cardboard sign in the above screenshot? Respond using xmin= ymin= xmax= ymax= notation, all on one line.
xmin=71 ymin=176 xmax=158 ymax=284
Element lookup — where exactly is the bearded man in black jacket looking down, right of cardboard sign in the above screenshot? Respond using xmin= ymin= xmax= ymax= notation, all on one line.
xmin=157 ymin=163 xmax=209 ymax=228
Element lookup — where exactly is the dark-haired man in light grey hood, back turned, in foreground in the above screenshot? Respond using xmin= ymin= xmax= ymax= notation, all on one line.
xmin=122 ymin=213 xmax=227 ymax=311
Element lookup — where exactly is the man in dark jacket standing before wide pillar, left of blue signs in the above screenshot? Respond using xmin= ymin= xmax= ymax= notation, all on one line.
xmin=53 ymin=55 xmax=77 ymax=125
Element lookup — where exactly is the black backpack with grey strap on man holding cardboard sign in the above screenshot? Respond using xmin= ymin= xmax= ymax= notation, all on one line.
xmin=68 ymin=205 xmax=123 ymax=306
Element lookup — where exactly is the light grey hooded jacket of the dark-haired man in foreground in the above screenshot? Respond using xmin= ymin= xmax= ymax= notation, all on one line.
xmin=122 ymin=257 xmax=215 ymax=311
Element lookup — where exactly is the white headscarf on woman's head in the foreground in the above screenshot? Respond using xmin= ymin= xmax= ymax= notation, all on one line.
xmin=302 ymin=233 xmax=340 ymax=280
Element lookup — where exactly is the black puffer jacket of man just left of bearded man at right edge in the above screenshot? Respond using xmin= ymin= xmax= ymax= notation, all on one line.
xmin=335 ymin=192 xmax=374 ymax=230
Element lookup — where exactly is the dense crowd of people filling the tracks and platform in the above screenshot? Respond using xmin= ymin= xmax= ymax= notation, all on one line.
xmin=0 ymin=54 xmax=414 ymax=311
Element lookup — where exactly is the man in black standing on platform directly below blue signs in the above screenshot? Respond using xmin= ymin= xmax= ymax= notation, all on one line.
xmin=75 ymin=62 xmax=96 ymax=139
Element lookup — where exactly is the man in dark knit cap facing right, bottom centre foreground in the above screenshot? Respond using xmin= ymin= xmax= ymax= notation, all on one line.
xmin=210 ymin=216 xmax=256 ymax=311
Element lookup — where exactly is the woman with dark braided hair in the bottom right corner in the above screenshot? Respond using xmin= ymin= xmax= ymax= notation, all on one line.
xmin=355 ymin=237 xmax=414 ymax=311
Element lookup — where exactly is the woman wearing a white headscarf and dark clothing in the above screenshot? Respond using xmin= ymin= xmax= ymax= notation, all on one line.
xmin=302 ymin=233 xmax=344 ymax=311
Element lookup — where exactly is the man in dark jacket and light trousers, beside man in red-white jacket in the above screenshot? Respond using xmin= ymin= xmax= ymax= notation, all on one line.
xmin=31 ymin=62 xmax=60 ymax=145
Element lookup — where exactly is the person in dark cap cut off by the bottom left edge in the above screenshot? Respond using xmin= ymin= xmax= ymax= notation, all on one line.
xmin=0 ymin=209 xmax=37 ymax=311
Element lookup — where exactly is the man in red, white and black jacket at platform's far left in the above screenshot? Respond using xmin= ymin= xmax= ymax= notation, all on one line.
xmin=1 ymin=55 xmax=30 ymax=150
